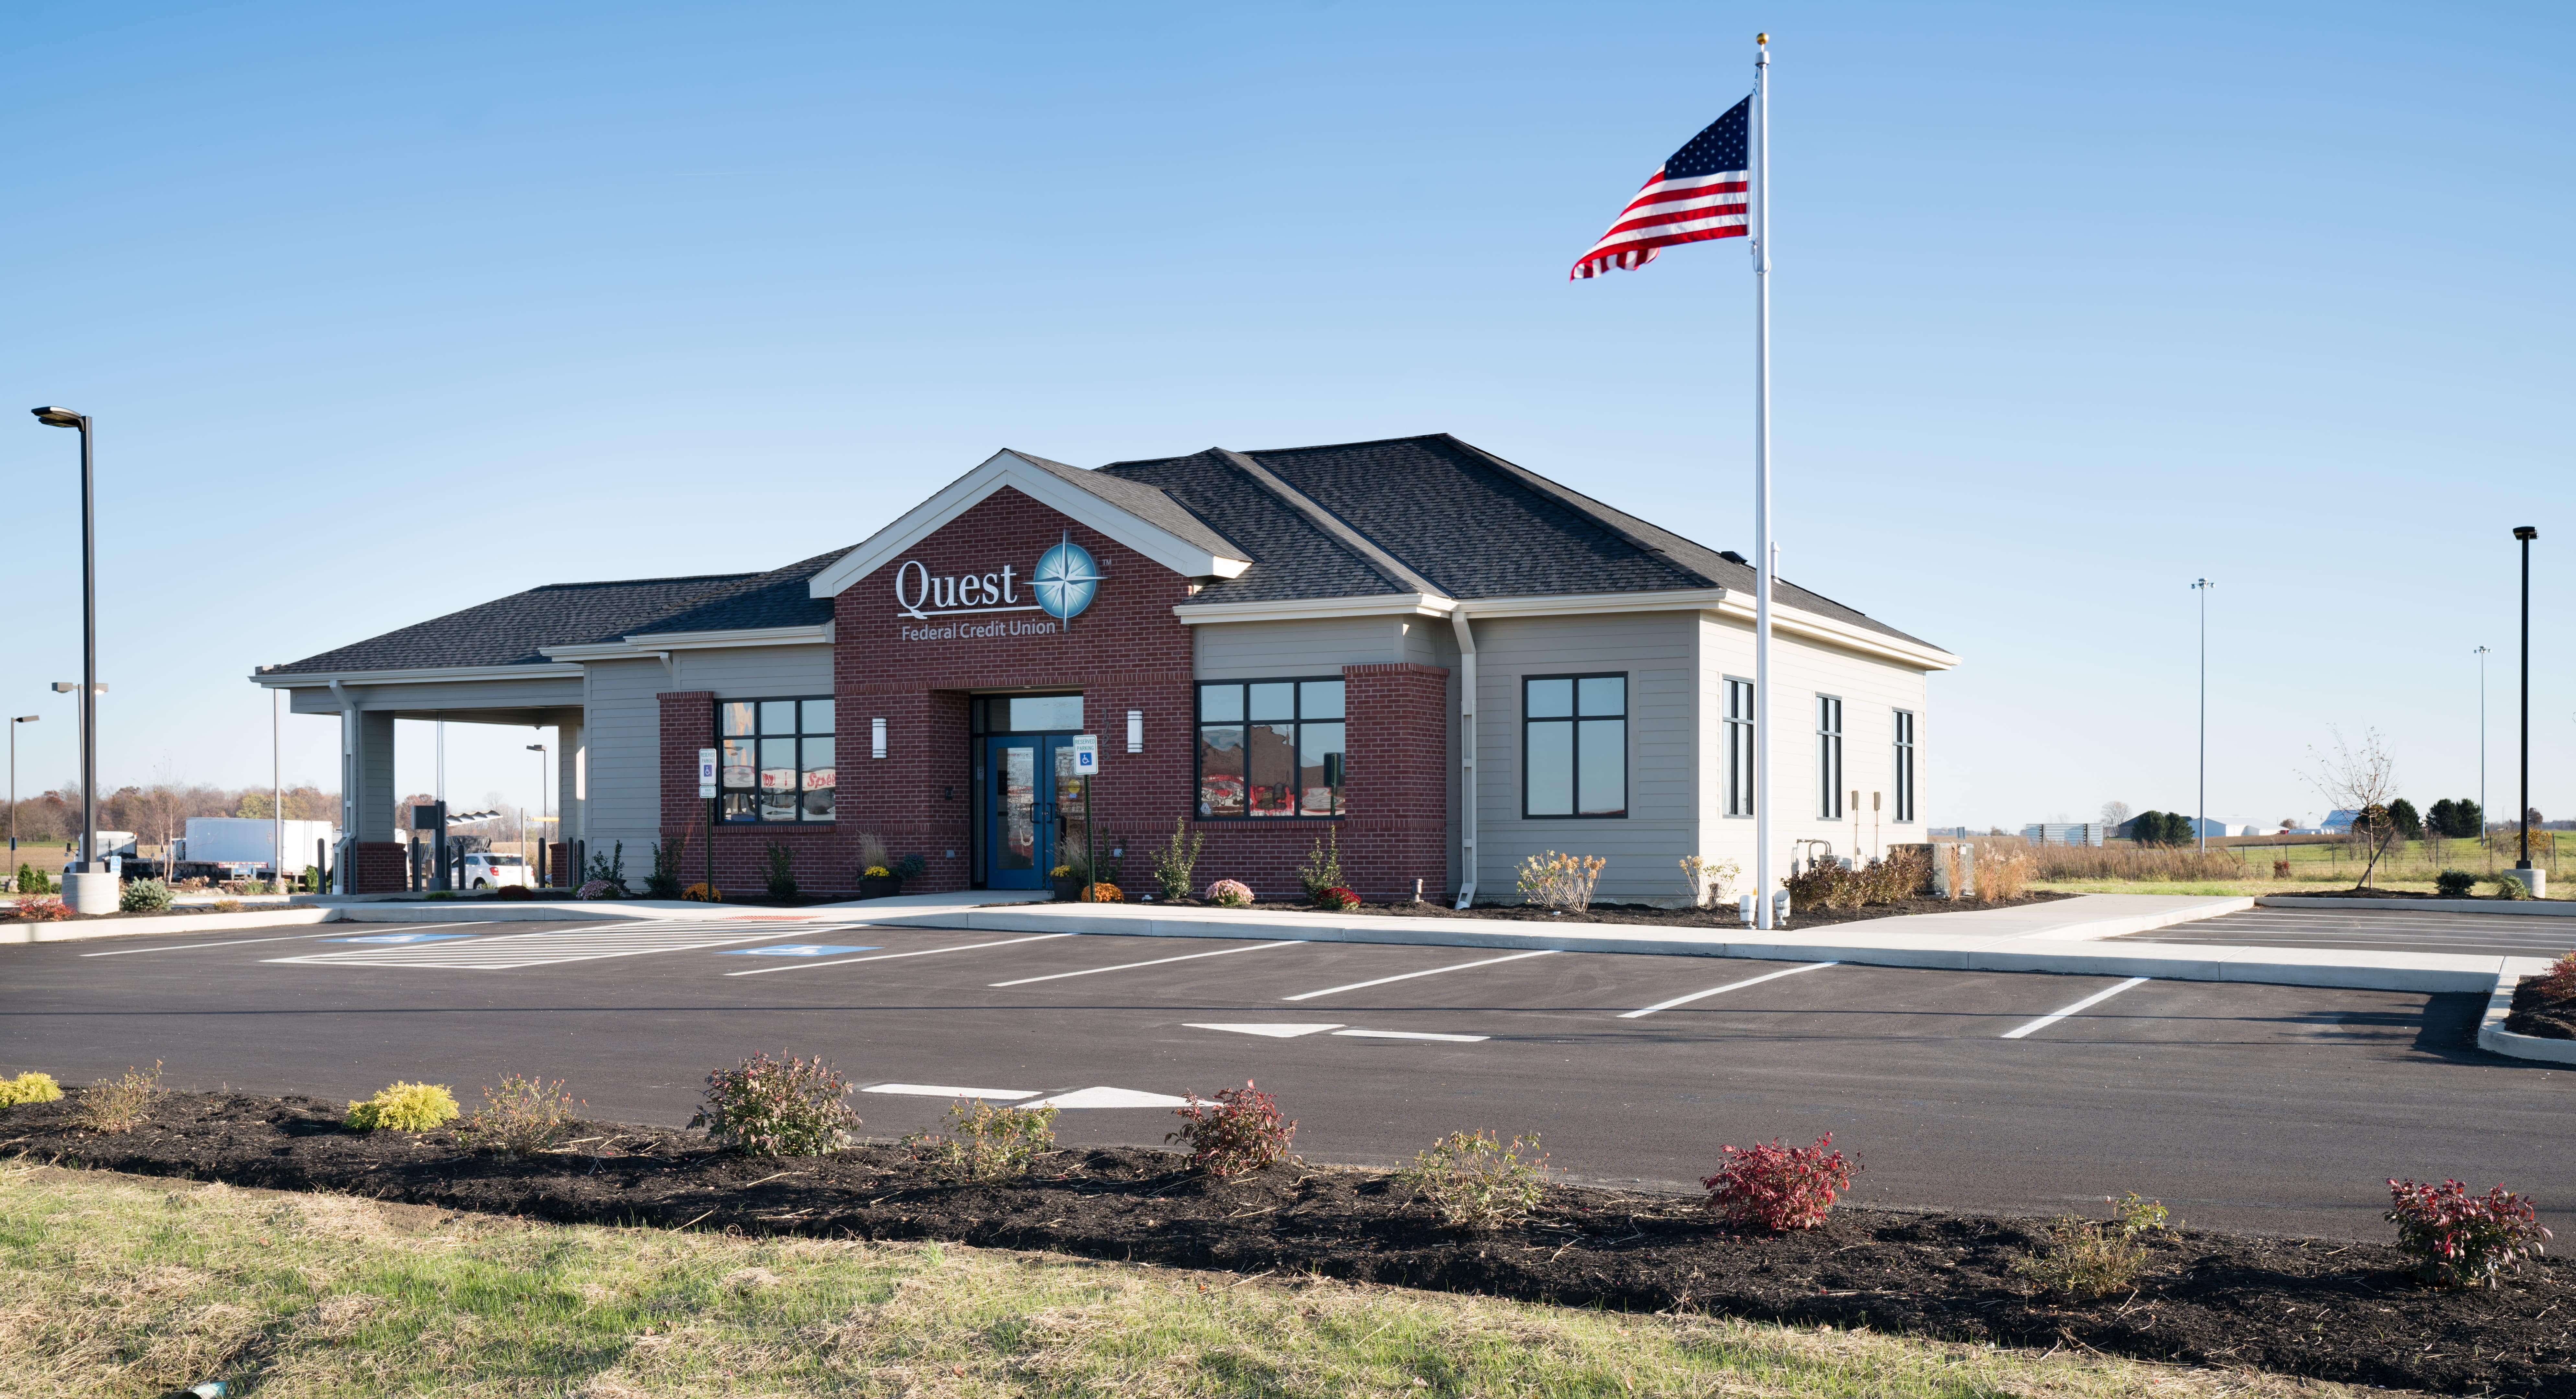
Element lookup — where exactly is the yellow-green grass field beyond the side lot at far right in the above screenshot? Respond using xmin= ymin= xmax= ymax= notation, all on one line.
xmin=2032 ymin=830 xmax=2576 ymax=899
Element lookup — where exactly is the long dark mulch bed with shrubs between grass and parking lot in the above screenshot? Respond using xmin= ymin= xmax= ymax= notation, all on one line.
xmin=0 ymin=1092 xmax=2576 ymax=1396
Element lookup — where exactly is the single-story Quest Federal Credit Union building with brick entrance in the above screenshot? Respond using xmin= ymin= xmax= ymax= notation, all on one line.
xmin=252 ymin=436 xmax=1958 ymax=902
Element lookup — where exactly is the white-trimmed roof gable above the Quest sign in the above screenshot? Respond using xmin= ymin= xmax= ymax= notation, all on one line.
xmin=809 ymin=448 xmax=1252 ymax=598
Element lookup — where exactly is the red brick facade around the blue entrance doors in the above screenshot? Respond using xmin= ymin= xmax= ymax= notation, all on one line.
xmin=659 ymin=487 xmax=1450 ymax=897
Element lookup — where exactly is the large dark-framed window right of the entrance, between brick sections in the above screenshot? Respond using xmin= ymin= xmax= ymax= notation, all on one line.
xmin=1198 ymin=680 xmax=1350 ymax=819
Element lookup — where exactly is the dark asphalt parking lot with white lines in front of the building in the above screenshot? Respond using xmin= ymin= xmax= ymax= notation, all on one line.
xmin=0 ymin=915 xmax=2576 ymax=1237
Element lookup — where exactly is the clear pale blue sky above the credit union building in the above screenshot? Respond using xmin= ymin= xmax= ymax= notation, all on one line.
xmin=0 ymin=3 xmax=2576 ymax=827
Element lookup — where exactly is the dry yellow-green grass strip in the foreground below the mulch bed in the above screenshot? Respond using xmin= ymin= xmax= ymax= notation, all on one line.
xmin=0 ymin=1167 xmax=2386 ymax=1399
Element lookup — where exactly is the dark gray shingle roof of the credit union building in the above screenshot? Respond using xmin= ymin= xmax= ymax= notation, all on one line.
xmin=273 ymin=433 xmax=1914 ymax=675
